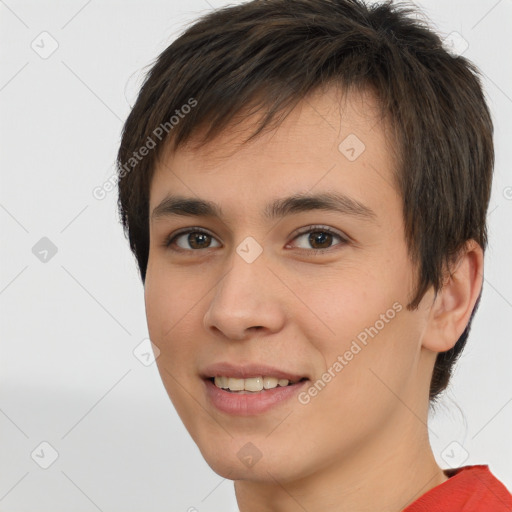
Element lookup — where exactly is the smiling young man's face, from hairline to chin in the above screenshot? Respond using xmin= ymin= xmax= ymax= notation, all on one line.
xmin=145 ymin=89 xmax=433 ymax=482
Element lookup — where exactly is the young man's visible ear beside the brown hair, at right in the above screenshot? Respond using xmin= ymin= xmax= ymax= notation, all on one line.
xmin=422 ymin=240 xmax=484 ymax=352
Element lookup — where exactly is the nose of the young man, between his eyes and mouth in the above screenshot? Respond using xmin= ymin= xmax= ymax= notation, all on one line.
xmin=203 ymin=248 xmax=286 ymax=341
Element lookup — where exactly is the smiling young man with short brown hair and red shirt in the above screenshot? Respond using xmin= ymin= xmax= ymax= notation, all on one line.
xmin=118 ymin=0 xmax=512 ymax=512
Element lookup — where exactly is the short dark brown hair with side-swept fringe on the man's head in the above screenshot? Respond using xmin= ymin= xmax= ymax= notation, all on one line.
xmin=117 ymin=0 xmax=494 ymax=401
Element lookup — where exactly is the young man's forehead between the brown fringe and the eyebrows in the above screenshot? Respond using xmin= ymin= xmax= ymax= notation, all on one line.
xmin=150 ymin=87 xmax=396 ymax=216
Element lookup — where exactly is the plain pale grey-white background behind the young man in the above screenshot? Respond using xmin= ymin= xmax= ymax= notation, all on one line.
xmin=0 ymin=0 xmax=512 ymax=512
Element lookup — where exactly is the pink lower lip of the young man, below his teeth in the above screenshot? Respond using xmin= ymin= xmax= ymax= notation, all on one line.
xmin=204 ymin=379 xmax=308 ymax=416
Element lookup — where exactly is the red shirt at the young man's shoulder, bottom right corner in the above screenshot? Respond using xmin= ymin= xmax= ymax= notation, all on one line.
xmin=402 ymin=465 xmax=512 ymax=512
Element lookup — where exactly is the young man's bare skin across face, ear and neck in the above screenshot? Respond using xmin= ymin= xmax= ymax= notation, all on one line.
xmin=145 ymin=88 xmax=483 ymax=512
